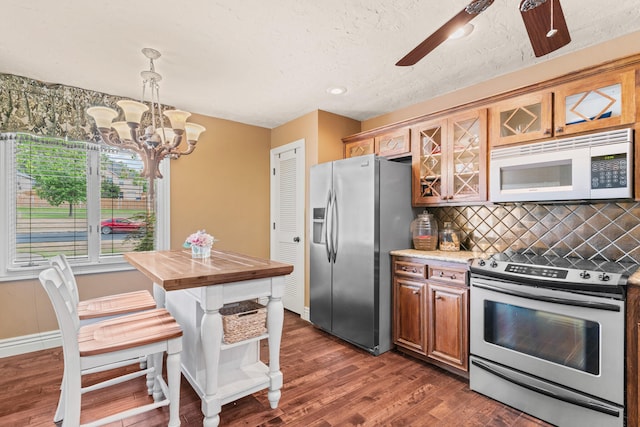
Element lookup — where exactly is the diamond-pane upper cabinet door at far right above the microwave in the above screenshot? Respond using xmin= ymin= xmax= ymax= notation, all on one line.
xmin=553 ymin=70 xmax=636 ymax=136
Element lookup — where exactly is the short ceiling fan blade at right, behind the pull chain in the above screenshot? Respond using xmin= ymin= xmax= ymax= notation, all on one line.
xmin=520 ymin=0 xmax=571 ymax=57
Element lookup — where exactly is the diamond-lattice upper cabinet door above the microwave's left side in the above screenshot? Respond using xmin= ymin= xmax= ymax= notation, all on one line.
xmin=489 ymin=91 xmax=553 ymax=147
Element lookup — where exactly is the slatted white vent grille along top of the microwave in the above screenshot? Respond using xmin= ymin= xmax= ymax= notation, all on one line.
xmin=491 ymin=129 xmax=632 ymax=159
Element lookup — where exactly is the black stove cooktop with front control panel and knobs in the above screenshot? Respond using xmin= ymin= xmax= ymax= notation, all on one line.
xmin=470 ymin=251 xmax=639 ymax=296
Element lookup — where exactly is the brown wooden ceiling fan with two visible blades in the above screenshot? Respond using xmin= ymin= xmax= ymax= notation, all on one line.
xmin=396 ymin=0 xmax=571 ymax=66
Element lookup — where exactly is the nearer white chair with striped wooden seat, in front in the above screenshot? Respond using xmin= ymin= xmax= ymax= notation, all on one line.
xmin=40 ymin=266 xmax=182 ymax=427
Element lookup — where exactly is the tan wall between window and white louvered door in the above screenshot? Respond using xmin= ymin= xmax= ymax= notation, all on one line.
xmin=171 ymin=115 xmax=271 ymax=258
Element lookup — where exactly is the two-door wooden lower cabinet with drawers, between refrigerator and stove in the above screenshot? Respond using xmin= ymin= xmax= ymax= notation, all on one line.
xmin=393 ymin=256 xmax=469 ymax=377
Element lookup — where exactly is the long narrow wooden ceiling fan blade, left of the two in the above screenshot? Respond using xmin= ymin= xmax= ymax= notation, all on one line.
xmin=396 ymin=0 xmax=493 ymax=67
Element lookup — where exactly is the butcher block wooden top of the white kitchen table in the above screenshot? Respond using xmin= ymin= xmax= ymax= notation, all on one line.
xmin=124 ymin=249 xmax=293 ymax=291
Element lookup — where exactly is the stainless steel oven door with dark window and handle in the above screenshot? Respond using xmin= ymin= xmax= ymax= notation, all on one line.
xmin=470 ymin=276 xmax=624 ymax=406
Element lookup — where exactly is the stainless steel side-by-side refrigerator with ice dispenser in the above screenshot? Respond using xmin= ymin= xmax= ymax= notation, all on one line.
xmin=309 ymin=155 xmax=413 ymax=355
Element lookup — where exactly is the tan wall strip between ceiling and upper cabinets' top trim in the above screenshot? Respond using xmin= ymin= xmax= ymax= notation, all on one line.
xmin=362 ymin=31 xmax=640 ymax=131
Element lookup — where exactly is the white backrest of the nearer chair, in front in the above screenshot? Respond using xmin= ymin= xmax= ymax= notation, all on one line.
xmin=39 ymin=266 xmax=80 ymax=354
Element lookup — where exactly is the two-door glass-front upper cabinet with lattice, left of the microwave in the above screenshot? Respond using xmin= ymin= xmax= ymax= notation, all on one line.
xmin=411 ymin=109 xmax=487 ymax=206
